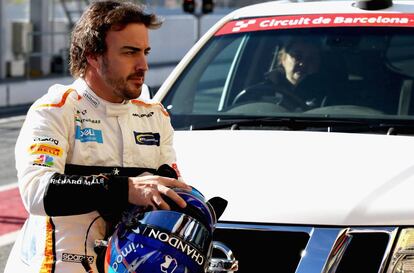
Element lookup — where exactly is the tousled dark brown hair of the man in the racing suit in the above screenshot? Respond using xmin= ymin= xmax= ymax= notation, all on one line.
xmin=70 ymin=0 xmax=162 ymax=78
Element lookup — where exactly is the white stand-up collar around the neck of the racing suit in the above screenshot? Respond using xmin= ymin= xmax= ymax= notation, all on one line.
xmin=74 ymin=78 xmax=131 ymax=117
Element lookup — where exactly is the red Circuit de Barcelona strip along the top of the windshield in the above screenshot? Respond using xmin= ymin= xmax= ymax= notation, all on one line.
xmin=215 ymin=13 xmax=414 ymax=36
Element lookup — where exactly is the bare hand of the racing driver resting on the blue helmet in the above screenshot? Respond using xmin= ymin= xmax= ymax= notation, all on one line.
xmin=128 ymin=175 xmax=191 ymax=210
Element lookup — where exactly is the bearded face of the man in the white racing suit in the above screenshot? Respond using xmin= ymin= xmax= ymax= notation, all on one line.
xmin=98 ymin=23 xmax=150 ymax=102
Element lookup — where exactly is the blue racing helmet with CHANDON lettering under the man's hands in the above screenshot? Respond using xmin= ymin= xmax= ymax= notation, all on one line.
xmin=104 ymin=188 xmax=227 ymax=273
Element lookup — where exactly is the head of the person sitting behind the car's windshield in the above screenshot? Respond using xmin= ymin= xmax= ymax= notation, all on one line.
xmin=282 ymin=42 xmax=321 ymax=85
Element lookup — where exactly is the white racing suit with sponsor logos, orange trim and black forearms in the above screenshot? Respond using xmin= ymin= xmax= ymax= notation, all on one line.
xmin=4 ymin=79 xmax=179 ymax=273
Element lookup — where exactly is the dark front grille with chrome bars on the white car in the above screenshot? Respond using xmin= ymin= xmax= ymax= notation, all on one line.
xmin=213 ymin=223 xmax=397 ymax=273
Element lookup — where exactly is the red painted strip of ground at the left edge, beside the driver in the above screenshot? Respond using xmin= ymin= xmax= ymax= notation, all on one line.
xmin=0 ymin=188 xmax=28 ymax=236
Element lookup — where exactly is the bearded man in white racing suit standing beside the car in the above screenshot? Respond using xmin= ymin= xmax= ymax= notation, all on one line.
xmin=5 ymin=1 xmax=189 ymax=273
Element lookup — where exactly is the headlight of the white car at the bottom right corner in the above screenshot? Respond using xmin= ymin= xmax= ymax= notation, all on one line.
xmin=387 ymin=228 xmax=414 ymax=273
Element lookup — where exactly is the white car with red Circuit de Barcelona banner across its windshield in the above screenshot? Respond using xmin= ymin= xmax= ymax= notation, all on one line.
xmin=154 ymin=0 xmax=414 ymax=273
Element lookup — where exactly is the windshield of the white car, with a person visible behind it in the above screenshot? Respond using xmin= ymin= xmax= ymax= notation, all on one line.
xmin=162 ymin=13 xmax=414 ymax=131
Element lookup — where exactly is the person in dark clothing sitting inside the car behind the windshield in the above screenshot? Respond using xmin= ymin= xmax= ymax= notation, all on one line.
xmin=233 ymin=37 xmax=344 ymax=111
